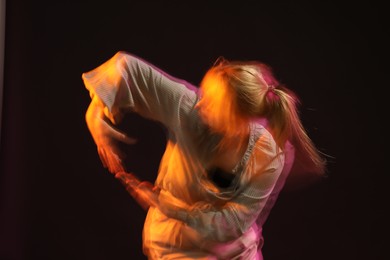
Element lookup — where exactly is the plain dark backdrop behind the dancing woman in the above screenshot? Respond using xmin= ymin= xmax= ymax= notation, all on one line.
xmin=0 ymin=0 xmax=388 ymax=260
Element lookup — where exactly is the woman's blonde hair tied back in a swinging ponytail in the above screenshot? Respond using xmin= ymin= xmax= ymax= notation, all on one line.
xmin=205 ymin=60 xmax=326 ymax=174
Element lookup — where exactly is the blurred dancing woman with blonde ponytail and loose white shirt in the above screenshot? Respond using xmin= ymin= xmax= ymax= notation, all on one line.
xmin=82 ymin=52 xmax=325 ymax=260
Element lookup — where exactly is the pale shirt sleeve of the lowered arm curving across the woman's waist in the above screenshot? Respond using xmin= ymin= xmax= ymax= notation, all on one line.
xmin=163 ymin=133 xmax=284 ymax=242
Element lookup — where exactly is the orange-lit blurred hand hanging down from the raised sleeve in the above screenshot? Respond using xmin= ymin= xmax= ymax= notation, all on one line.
xmin=85 ymin=96 xmax=136 ymax=174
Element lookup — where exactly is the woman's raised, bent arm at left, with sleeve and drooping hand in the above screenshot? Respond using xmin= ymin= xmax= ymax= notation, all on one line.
xmin=82 ymin=52 xmax=196 ymax=173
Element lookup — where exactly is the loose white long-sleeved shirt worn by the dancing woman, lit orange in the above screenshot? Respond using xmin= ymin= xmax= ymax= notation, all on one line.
xmin=83 ymin=52 xmax=293 ymax=260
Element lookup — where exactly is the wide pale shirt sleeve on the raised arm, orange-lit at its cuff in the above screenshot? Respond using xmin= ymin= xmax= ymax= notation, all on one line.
xmin=82 ymin=51 xmax=197 ymax=127
